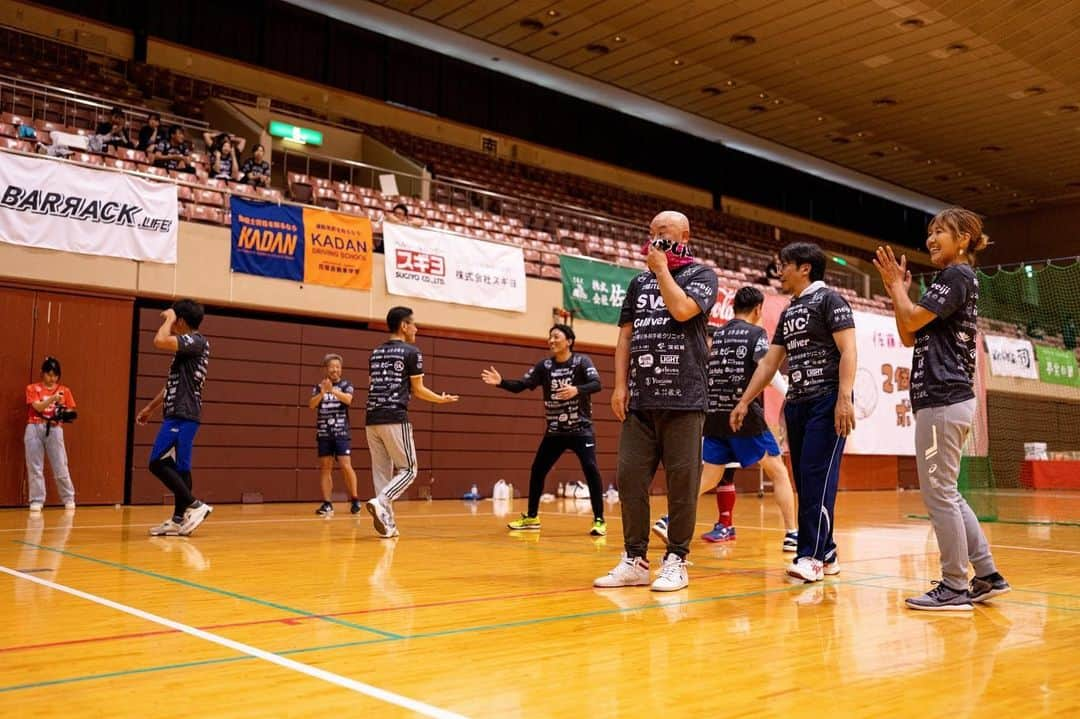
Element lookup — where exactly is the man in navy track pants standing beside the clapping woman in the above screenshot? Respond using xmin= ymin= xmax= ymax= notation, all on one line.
xmin=731 ymin=242 xmax=858 ymax=582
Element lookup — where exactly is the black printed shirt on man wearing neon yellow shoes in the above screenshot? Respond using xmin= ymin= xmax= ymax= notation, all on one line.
xmin=499 ymin=353 xmax=600 ymax=436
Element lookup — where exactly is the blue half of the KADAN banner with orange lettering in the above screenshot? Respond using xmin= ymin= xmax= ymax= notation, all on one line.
xmin=229 ymin=195 xmax=303 ymax=282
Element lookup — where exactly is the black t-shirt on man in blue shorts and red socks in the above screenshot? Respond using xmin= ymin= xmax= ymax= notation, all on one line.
xmin=705 ymin=320 xmax=769 ymax=437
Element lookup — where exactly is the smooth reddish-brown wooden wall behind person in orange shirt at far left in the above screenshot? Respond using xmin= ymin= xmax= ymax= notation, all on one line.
xmin=0 ymin=286 xmax=132 ymax=506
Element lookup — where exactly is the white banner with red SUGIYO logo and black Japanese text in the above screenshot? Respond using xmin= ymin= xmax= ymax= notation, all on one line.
xmin=382 ymin=222 xmax=526 ymax=312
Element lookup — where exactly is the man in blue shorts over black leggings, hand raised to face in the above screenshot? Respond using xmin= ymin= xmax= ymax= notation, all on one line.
xmin=135 ymin=299 xmax=214 ymax=537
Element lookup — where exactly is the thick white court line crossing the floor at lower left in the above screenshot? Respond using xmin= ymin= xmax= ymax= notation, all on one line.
xmin=0 ymin=565 xmax=465 ymax=719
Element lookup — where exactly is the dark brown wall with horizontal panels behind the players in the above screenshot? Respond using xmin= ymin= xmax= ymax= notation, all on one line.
xmin=132 ymin=309 xmax=626 ymax=503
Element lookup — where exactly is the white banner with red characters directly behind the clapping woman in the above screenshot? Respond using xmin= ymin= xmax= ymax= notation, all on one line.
xmin=845 ymin=312 xmax=915 ymax=456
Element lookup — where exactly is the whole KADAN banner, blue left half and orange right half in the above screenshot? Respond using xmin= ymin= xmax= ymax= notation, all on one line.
xmin=229 ymin=196 xmax=372 ymax=289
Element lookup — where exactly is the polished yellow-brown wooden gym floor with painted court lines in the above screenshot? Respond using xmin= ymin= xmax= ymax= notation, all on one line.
xmin=0 ymin=492 xmax=1080 ymax=719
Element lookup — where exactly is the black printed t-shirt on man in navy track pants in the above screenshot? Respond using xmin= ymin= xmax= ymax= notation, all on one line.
xmin=772 ymin=283 xmax=855 ymax=402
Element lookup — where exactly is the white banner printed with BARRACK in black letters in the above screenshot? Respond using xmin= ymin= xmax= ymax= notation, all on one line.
xmin=0 ymin=152 xmax=178 ymax=264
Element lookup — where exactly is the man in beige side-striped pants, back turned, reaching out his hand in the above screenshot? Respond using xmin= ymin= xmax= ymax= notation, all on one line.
xmin=365 ymin=307 xmax=458 ymax=539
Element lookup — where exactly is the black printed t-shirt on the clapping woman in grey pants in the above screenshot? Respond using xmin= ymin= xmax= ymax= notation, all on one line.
xmin=912 ymin=263 xmax=978 ymax=410
